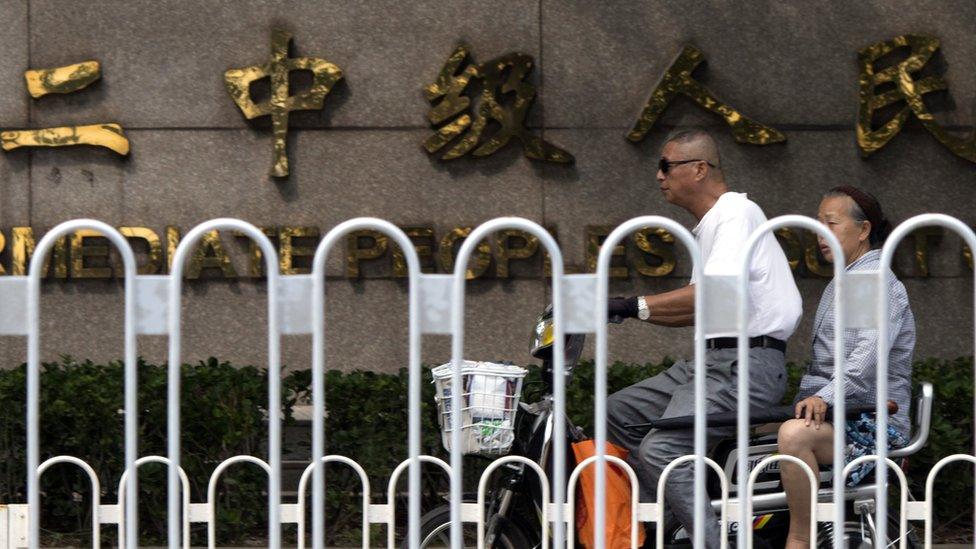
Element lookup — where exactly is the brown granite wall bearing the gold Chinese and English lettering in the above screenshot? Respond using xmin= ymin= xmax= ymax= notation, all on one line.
xmin=0 ymin=0 xmax=976 ymax=371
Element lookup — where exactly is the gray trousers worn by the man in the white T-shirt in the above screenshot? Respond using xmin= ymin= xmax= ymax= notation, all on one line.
xmin=607 ymin=347 xmax=786 ymax=548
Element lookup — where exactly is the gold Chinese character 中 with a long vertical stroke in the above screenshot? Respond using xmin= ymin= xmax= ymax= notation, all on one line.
xmin=224 ymin=29 xmax=342 ymax=177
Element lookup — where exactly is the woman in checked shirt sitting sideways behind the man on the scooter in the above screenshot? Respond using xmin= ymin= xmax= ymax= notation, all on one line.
xmin=779 ymin=186 xmax=915 ymax=549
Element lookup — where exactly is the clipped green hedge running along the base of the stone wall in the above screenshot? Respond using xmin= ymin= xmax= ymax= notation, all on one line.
xmin=0 ymin=357 xmax=973 ymax=545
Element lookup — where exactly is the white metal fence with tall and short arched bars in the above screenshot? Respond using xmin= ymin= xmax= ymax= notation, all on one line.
xmin=0 ymin=214 xmax=976 ymax=549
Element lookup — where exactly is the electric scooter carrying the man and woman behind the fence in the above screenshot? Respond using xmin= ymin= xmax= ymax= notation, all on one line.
xmin=404 ymin=309 xmax=933 ymax=549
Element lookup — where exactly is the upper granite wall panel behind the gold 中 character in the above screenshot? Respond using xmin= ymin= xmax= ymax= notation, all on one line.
xmin=31 ymin=0 xmax=539 ymax=128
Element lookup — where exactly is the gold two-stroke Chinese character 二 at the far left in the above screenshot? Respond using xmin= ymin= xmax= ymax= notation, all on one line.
xmin=0 ymin=61 xmax=129 ymax=156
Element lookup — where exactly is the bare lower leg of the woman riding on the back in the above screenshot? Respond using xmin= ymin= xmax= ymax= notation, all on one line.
xmin=778 ymin=419 xmax=834 ymax=549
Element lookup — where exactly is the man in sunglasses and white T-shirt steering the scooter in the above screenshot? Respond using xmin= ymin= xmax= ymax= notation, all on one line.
xmin=607 ymin=130 xmax=801 ymax=548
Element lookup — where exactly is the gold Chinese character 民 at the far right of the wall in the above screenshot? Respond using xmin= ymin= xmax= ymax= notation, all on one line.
xmin=857 ymin=34 xmax=976 ymax=162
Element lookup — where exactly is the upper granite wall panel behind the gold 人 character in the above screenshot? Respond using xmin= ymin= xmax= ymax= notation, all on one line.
xmin=542 ymin=0 xmax=976 ymax=128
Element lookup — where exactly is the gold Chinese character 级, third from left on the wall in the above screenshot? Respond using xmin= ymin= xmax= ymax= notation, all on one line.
xmin=424 ymin=45 xmax=573 ymax=163
